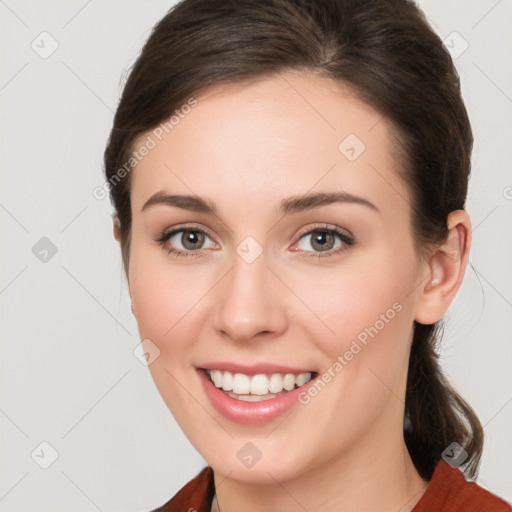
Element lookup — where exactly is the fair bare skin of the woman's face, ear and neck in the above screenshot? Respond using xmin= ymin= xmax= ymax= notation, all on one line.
xmin=114 ymin=72 xmax=471 ymax=512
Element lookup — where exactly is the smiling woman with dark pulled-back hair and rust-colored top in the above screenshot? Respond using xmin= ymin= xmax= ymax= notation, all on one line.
xmin=105 ymin=0 xmax=511 ymax=512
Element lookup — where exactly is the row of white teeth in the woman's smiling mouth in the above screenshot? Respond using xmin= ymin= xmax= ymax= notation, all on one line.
xmin=208 ymin=370 xmax=311 ymax=396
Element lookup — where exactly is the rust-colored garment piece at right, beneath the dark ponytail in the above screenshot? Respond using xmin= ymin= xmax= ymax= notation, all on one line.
xmin=412 ymin=459 xmax=512 ymax=512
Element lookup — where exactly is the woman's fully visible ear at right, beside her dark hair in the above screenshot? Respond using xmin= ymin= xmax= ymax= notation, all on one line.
xmin=414 ymin=210 xmax=471 ymax=325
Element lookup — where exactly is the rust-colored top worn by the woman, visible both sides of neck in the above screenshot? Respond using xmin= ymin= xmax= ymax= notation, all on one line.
xmin=152 ymin=459 xmax=512 ymax=512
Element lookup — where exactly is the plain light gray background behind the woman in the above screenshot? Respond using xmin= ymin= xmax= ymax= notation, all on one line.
xmin=0 ymin=0 xmax=512 ymax=512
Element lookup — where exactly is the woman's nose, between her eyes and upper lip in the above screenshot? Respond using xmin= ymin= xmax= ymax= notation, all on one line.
xmin=214 ymin=249 xmax=287 ymax=343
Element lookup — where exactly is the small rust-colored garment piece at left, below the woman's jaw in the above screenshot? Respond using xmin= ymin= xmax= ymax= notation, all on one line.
xmin=151 ymin=466 xmax=215 ymax=512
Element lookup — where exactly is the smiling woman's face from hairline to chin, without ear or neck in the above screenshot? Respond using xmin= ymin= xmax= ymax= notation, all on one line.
xmin=129 ymin=72 xmax=426 ymax=482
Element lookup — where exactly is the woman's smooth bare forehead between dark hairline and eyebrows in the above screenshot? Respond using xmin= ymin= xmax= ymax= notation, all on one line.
xmin=131 ymin=72 xmax=407 ymax=216
